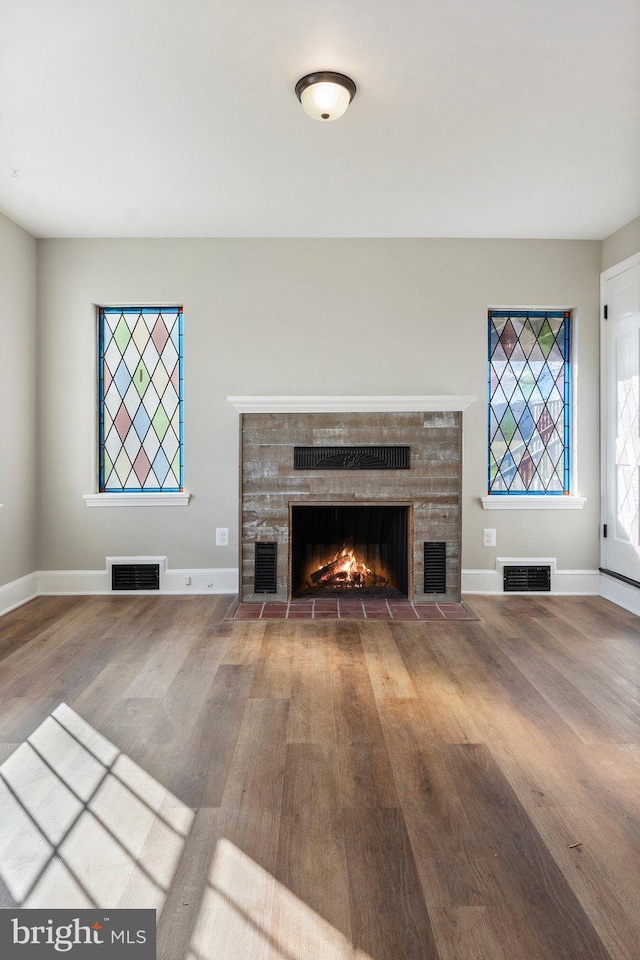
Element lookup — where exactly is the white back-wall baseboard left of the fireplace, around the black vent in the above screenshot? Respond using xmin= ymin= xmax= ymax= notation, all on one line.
xmin=37 ymin=558 xmax=238 ymax=596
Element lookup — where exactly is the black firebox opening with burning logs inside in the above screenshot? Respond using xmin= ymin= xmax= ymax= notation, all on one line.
xmin=290 ymin=503 xmax=410 ymax=599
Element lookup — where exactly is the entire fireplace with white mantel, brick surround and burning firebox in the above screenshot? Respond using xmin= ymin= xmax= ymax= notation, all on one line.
xmin=230 ymin=397 xmax=473 ymax=603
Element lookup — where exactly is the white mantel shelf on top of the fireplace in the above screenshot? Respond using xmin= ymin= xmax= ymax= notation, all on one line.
xmin=227 ymin=394 xmax=476 ymax=413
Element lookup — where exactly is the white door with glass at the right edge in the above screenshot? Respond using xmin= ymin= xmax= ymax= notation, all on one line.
xmin=602 ymin=263 xmax=640 ymax=582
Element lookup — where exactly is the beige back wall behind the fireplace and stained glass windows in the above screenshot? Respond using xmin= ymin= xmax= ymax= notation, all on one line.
xmin=39 ymin=240 xmax=601 ymax=569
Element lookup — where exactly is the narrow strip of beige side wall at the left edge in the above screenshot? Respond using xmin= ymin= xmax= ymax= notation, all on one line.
xmin=0 ymin=214 xmax=37 ymax=586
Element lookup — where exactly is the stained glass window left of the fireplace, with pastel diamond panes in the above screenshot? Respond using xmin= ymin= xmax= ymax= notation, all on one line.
xmin=98 ymin=307 xmax=183 ymax=493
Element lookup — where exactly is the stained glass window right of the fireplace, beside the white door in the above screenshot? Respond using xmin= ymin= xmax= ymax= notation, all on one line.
xmin=489 ymin=310 xmax=571 ymax=495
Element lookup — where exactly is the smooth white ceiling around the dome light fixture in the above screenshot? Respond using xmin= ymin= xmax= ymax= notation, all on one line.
xmin=0 ymin=0 xmax=640 ymax=238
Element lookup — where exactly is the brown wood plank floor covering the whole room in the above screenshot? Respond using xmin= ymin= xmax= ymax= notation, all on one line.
xmin=0 ymin=597 xmax=640 ymax=960
